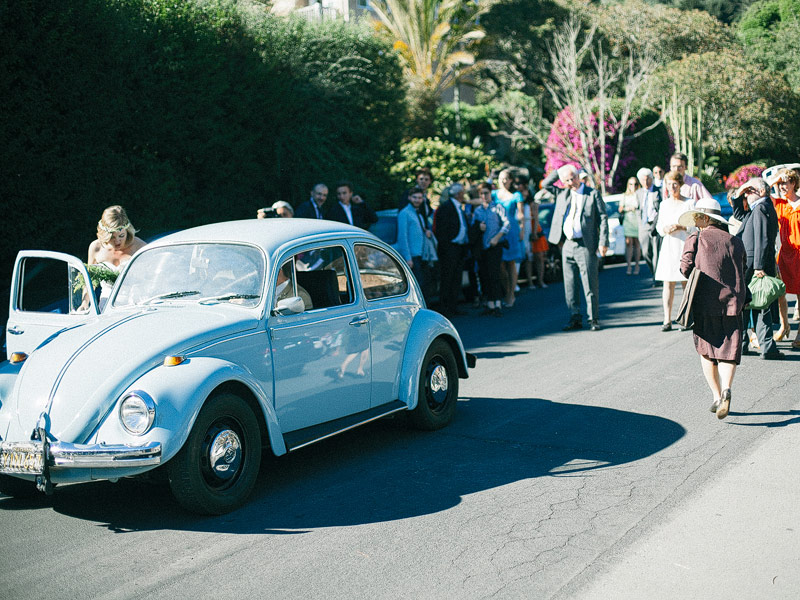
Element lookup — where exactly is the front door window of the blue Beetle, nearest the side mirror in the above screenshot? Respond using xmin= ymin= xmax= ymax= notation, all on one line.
xmin=292 ymin=246 xmax=355 ymax=310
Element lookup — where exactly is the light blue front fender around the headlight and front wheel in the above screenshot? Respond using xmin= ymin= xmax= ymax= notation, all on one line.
xmin=92 ymin=357 xmax=286 ymax=464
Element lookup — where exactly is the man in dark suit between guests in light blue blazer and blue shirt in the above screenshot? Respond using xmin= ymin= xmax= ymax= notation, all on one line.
xmin=433 ymin=183 xmax=469 ymax=317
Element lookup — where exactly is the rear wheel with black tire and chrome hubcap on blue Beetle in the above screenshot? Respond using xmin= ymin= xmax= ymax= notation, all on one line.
xmin=409 ymin=340 xmax=458 ymax=431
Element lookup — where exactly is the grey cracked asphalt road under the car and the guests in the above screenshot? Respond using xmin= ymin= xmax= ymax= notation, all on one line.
xmin=0 ymin=267 xmax=800 ymax=600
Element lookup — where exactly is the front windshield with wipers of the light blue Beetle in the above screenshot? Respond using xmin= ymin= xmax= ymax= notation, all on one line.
xmin=113 ymin=244 xmax=265 ymax=307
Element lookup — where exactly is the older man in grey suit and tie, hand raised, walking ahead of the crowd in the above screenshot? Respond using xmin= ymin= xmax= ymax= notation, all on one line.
xmin=542 ymin=165 xmax=608 ymax=331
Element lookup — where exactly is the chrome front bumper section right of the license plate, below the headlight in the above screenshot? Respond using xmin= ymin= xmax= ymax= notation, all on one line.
xmin=50 ymin=442 xmax=161 ymax=469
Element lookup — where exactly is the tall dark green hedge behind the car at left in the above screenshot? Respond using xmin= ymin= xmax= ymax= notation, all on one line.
xmin=0 ymin=0 xmax=406 ymax=279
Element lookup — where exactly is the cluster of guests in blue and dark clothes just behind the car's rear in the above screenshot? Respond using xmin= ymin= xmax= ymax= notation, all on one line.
xmin=395 ymin=168 xmax=549 ymax=317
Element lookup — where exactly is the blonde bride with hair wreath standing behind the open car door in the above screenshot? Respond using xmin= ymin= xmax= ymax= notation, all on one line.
xmin=87 ymin=206 xmax=145 ymax=310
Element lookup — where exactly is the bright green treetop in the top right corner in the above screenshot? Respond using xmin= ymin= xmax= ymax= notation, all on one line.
xmin=737 ymin=0 xmax=800 ymax=91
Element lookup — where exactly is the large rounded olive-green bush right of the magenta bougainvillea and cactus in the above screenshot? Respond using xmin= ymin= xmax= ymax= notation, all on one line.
xmin=653 ymin=50 xmax=800 ymax=171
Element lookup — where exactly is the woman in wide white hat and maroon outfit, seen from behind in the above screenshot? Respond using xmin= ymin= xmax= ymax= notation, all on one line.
xmin=678 ymin=198 xmax=747 ymax=419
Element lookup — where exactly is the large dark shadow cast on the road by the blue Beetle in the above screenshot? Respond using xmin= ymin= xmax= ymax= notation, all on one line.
xmin=0 ymin=398 xmax=685 ymax=534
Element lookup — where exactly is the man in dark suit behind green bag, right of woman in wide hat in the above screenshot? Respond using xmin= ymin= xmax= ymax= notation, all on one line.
xmin=733 ymin=177 xmax=784 ymax=360
